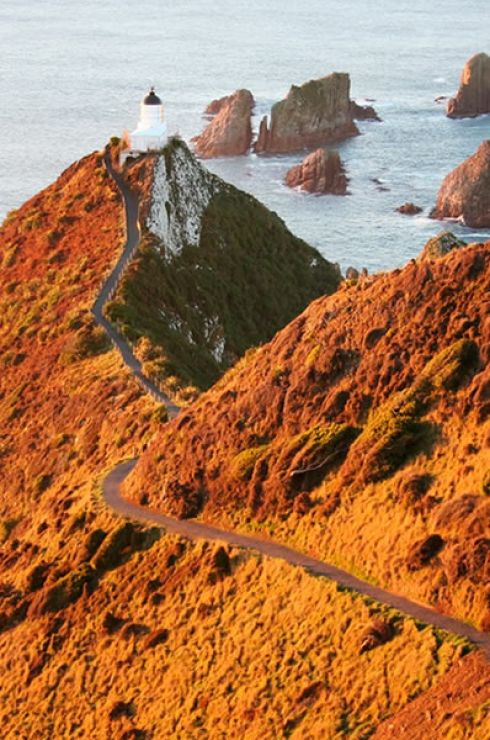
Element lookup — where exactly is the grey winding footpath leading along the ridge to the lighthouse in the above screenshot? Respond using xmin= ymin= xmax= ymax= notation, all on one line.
xmin=92 ymin=150 xmax=490 ymax=660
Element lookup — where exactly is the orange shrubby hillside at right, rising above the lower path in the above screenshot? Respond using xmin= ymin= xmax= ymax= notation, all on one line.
xmin=125 ymin=235 xmax=490 ymax=629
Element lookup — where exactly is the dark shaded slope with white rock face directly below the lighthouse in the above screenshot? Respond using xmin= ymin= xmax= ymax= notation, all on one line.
xmin=108 ymin=141 xmax=340 ymax=402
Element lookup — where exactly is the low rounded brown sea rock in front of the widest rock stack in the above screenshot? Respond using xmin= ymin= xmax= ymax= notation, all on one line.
xmin=286 ymin=149 xmax=347 ymax=195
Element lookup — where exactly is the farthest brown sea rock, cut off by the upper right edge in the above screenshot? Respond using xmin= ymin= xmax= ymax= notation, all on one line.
xmin=447 ymin=52 xmax=490 ymax=118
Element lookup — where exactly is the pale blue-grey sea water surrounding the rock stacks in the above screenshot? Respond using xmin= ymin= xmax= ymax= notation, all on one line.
xmin=0 ymin=0 xmax=490 ymax=271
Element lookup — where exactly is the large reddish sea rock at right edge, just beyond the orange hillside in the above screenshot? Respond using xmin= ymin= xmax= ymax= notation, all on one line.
xmin=431 ymin=139 xmax=490 ymax=229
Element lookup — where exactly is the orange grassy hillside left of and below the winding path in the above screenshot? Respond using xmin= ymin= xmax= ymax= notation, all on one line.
xmin=0 ymin=153 xmax=490 ymax=740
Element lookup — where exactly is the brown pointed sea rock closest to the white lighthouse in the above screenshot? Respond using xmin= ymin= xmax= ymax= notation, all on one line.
xmin=193 ymin=90 xmax=254 ymax=159
